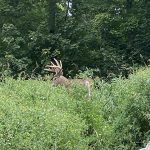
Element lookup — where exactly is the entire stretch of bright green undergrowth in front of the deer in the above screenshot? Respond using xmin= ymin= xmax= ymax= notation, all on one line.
xmin=0 ymin=68 xmax=150 ymax=150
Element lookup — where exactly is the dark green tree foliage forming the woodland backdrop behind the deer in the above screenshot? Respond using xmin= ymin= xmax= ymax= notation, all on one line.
xmin=0 ymin=0 xmax=150 ymax=76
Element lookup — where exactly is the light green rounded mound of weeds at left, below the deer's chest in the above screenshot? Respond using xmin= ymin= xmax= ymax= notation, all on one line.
xmin=0 ymin=79 xmax=87 ymax=150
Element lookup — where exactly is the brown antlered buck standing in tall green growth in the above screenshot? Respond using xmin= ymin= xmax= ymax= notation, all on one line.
xmin=44 ymin=59 xmax=93 ymax=98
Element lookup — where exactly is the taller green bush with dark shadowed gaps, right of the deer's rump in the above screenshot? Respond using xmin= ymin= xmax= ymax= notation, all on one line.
xmin=89 ymin=68 xmax=150 ymax=150
